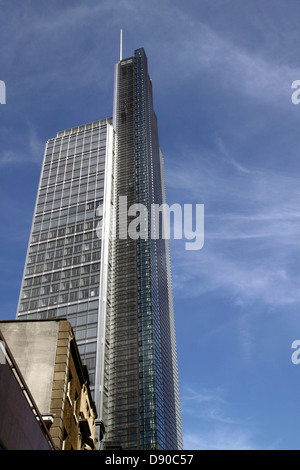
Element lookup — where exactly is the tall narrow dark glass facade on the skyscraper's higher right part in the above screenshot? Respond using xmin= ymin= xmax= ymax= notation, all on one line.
xmin=107 ymin=49 xmax=182 ymax=449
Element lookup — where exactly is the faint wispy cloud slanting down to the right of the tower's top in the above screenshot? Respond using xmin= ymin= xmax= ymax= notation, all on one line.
xmin=170 ymin=18 xmax=300 ymax=106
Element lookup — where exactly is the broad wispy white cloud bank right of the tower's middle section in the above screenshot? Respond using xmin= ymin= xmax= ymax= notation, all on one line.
xmin=167 ymin=143 xmax=300 ymax=305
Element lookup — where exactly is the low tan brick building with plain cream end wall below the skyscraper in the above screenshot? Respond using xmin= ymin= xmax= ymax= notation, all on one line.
xmin=0 ymin=319 xmax=104 ymax=450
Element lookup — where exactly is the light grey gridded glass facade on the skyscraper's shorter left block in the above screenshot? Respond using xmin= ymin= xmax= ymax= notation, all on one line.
xmin=17 ymin=119 xmax=112 ymax=391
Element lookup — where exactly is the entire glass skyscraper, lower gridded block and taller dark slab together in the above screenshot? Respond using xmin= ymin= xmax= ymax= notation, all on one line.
xmin=18 ymin=49 xmax=182 ymax=450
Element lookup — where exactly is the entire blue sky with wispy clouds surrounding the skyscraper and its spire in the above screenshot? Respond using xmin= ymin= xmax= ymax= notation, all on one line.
xmin=0 ymin=0 xmax=300 ymax=449
